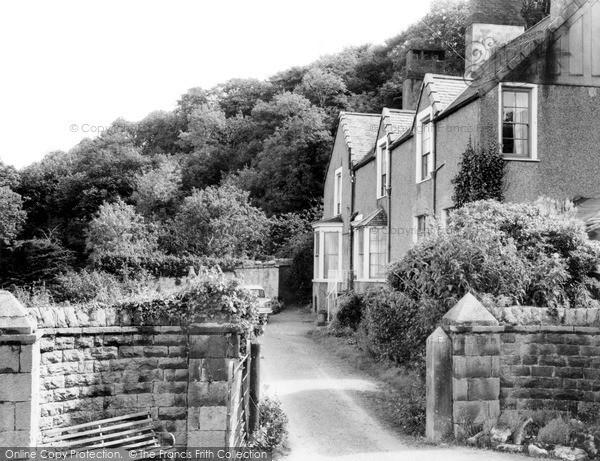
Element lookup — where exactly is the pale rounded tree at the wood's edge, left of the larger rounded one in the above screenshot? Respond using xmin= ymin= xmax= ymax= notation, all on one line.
xmin=86 ymin=200 xmax=157 ymax=259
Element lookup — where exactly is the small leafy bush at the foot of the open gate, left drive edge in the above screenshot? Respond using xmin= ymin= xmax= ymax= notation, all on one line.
xmin=248 ymin=396 xmax=288 ymax=451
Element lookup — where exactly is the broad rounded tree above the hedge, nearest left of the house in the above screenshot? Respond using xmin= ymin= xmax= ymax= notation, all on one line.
xmin=172 ymin=184 xmax=267 ymax=257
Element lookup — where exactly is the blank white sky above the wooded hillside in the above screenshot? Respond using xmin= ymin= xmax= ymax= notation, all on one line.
xmin=0 ymin=0 xmax=431 ymax=168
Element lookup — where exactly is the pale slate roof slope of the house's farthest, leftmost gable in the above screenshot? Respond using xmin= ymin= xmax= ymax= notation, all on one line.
xmin=340 ymin=112 xmax=381 ymax=162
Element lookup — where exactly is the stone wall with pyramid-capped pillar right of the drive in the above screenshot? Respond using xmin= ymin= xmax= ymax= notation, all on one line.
xmin=428 ymin=295 xmax=600 ymax=439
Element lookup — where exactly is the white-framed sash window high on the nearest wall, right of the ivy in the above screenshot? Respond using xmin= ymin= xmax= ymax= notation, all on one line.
xmin=499 ymin=84 xmax=537 ymax=160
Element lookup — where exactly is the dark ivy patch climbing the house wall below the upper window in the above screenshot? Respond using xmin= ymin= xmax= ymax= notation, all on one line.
xmin=452 ymin=140 xmax=506 ymax=208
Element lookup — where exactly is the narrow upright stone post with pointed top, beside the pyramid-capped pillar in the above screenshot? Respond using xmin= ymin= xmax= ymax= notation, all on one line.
xmin=426 ymin=327 xmax=453 ymax=442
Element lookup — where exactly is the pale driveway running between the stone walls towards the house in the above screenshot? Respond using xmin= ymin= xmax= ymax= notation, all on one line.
xmin=261 ymin=309 xmax=531 ymax=461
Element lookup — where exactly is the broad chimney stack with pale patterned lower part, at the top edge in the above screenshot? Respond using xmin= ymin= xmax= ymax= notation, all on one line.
xmin=465 ymin=0 xmax=524 ymax=77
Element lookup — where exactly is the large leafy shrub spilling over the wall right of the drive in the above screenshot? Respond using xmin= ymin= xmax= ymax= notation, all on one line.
xmin=388 ymin=200 xmax=600 ymax=310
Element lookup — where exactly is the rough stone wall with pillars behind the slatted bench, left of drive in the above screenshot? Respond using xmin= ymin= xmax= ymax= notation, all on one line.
xmin=0 ymin=292 xmax=247 ymax=447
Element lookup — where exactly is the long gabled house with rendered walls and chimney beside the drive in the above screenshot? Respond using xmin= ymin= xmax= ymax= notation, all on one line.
xmin=313 ymin=0 xmax=600 ymax=309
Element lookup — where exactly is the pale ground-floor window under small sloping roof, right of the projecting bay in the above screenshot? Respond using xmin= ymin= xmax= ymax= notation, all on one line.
xmin=354 ymin=227 xmax=387 ymax=281
